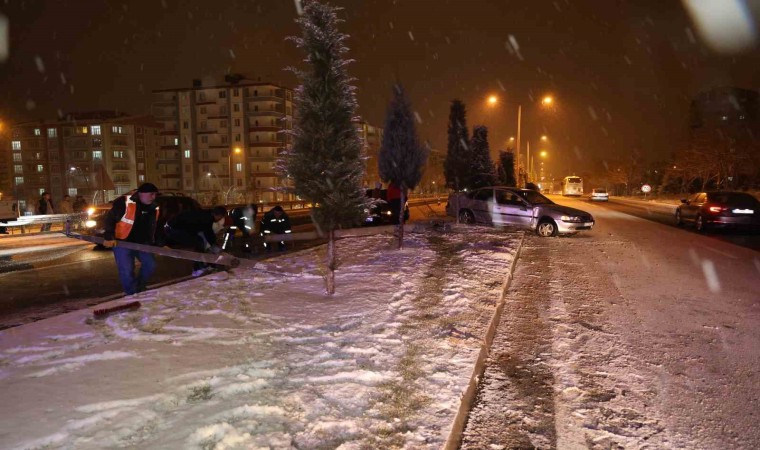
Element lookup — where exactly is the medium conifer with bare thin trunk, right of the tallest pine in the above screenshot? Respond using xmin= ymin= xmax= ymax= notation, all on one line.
xmin=378 ymin=84 xmax=428 ymax=248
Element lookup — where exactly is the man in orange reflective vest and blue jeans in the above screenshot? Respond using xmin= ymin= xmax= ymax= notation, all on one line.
xmin=103 ymin=183 xmax=162 ymax=295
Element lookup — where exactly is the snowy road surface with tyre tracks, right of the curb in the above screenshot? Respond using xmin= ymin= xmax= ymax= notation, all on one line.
xmin=462 ymin=199 xmax=760 ymax=449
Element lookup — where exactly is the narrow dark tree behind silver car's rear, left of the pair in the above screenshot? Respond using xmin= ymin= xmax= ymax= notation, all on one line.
xmin=443 ymin=100 xmax=470 ymax=191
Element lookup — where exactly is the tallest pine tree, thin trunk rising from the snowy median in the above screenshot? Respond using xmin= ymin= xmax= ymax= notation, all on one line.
xmin=280 ymin=1 xmax=367 ymax=295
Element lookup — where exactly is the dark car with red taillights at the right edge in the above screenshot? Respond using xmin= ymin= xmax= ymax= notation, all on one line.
xmin=676 ymin=191 xmax=760 ymax=231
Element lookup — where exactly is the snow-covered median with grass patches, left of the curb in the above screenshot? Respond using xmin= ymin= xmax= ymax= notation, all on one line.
xmin=0 ymin=227 xmax=522 ymax=449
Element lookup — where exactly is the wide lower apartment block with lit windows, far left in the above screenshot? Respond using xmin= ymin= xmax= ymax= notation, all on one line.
xmin=10 ymin=111 xmax=159 ymax=211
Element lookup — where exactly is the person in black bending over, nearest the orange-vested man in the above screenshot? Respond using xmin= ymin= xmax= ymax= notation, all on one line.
xmin=164 ymin=206 xmax=227 ymax=277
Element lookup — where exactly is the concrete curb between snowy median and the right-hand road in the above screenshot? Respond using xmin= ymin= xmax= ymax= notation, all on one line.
xmin=443 ymin=233 xmax=525 ymax=450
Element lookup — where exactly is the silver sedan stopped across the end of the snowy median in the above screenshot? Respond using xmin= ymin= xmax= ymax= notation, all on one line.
xmin=446 ymin=186 xmax=595 ymax=237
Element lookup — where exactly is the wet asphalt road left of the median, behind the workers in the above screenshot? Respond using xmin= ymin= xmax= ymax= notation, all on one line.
xmin=0 ymin=201 xmax=445 ymax=329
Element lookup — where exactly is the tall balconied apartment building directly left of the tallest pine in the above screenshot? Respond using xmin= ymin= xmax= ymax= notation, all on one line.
xmin=151 ymin=75 xmax=293 ymax=203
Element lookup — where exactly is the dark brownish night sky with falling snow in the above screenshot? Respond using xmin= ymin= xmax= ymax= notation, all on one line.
xmin=0 ymin=0 xmax=760 ymax=176
